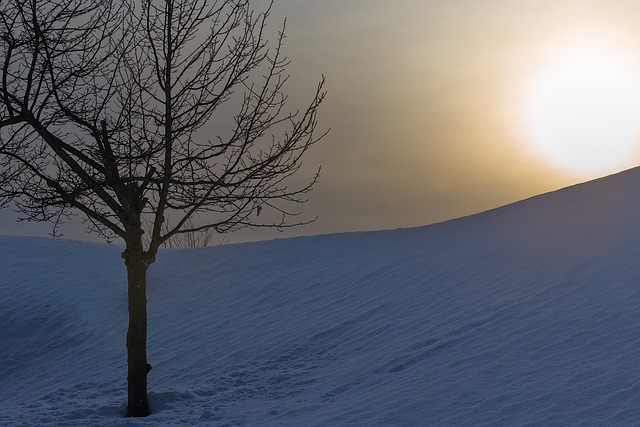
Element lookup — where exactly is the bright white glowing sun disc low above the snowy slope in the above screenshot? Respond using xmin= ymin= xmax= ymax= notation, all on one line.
xmin=525 ymin=50 xmax=640 ymax=175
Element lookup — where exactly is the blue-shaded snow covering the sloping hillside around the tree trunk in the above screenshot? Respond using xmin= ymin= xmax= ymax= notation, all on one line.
xmin=0 ymin=169 xmax=640 ymax=426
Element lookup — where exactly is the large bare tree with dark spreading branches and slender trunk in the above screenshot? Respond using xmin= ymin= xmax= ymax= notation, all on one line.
xmin=0 ymin=0 xmax=325 ymax=416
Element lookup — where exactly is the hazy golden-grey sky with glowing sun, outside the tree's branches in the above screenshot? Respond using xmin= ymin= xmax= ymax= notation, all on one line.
xmin=0 ymin=0 xmax=640 ymax=242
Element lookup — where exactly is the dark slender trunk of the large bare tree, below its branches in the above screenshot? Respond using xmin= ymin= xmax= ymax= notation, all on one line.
xmin=123 ymin=235 xmax=149 ymax=417
